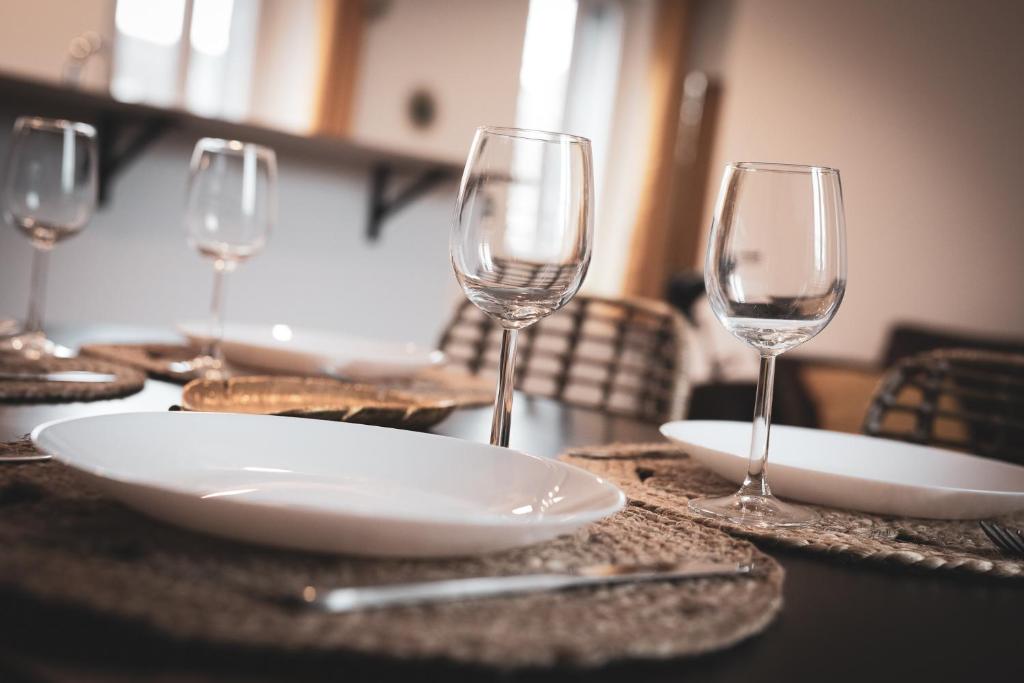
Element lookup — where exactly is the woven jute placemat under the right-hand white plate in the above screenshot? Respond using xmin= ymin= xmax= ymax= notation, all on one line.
xmin=563 ymin=443 xmax=1024 ymax=580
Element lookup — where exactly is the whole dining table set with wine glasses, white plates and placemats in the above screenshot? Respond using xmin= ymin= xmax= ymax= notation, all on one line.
xmin=0 ymin=117 xmax=1024 ymax=682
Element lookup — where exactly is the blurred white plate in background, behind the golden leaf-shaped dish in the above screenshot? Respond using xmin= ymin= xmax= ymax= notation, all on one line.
xmin=178 ymin=323 xmax=444 ymax=380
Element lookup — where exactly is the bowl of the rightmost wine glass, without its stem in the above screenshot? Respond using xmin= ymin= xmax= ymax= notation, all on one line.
xmin=705 ymin=163 xmax=846 ymax=353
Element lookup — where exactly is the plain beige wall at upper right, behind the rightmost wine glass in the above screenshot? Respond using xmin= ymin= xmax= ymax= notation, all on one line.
xmin=691 ymin=0 xmax=1024 ymax=359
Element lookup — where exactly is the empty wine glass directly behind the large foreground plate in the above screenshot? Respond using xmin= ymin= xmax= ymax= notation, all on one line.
xmin=450 ymin=126 xmax=594 ymax=446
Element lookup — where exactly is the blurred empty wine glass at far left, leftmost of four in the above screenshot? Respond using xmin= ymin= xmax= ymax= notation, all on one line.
xmin=0 ymin=117 xmax=97 ymax=358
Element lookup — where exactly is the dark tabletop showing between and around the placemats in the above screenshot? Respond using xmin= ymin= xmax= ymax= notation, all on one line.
xmin=0 ymin=329 xmax=1024 ymax=682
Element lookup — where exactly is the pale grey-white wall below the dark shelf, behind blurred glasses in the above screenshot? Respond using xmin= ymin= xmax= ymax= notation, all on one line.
xmin=0 ymin=115 xmax=462 ymax=343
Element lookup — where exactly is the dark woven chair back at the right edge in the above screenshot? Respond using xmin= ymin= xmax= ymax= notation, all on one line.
xmin=863 ymin=349 xmax=1024 ymax=464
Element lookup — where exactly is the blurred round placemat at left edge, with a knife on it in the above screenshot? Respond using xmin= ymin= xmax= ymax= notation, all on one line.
xmin=0 ymin=353 xmax=145 ymax=402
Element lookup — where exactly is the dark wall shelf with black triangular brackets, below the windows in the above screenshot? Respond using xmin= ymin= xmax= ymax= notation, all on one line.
xmin=0 ymin=74 xmax=462 ymax=241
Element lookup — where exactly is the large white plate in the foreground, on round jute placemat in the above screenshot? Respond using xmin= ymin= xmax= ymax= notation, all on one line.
xmin=32 ymin=412 xmax=626 ymax=557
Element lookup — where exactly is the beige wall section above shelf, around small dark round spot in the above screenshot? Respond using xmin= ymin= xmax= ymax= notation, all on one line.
xmin=352 ymin=0 xmax=528 ymax=164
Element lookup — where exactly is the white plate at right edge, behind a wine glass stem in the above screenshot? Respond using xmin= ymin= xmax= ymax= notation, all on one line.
xmin=662 ymin=420 xmax=1024 ymax=519
